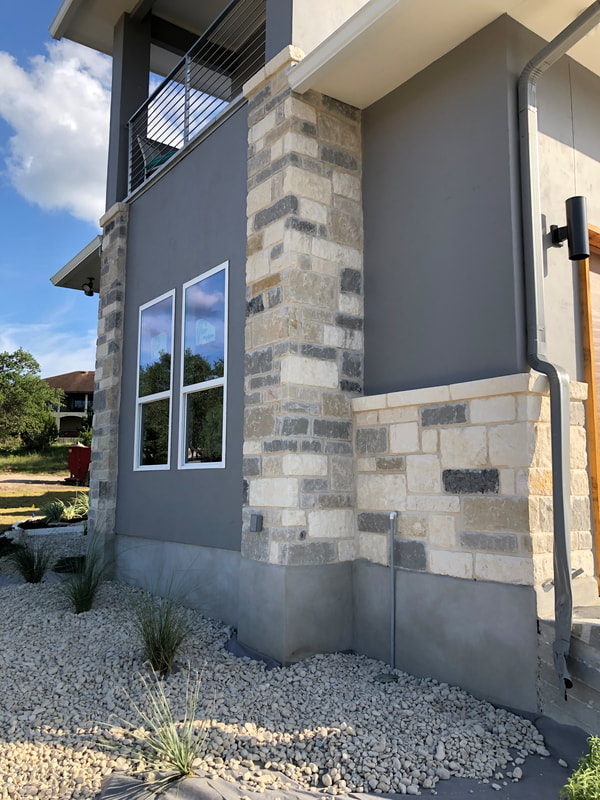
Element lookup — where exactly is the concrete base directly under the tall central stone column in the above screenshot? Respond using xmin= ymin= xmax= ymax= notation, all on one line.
xmin=238 ymin=558 xmax=352 ymax=663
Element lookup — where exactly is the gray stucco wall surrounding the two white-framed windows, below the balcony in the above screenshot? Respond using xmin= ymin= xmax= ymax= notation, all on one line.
xmin=116 ymin=105 xmax=248 ymax=550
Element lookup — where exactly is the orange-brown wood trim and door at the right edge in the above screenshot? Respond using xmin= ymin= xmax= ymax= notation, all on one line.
xmin=579 ymin=226 xmax=600 ymax=592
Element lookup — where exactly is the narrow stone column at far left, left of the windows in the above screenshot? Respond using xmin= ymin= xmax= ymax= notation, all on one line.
xmin=88 ymin=203 xmax=129 ymax=564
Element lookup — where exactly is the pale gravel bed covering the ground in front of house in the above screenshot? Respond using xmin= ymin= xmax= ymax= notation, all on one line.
xmin=0 ymin=583 xmax=548 ymax=800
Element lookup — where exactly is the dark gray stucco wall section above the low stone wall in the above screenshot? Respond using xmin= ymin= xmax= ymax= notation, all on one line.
xmin=363 ymin=17 xmax=525 ymax=394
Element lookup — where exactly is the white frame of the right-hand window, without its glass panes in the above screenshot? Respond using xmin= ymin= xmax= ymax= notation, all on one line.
xmin=177 ymin=261 xmax=229 ymax=469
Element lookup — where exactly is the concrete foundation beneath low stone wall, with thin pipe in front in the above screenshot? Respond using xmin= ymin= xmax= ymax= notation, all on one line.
xmin=352 ymin=561 xmax=536 ymax=711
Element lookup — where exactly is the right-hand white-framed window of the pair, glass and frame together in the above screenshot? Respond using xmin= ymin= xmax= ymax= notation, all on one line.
xmin=179 ymin=261 xmax=229 ymax=469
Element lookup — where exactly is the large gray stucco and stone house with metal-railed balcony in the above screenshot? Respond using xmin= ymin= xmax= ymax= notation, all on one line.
xmin=51 ymin=0 xmax=600 ymax=730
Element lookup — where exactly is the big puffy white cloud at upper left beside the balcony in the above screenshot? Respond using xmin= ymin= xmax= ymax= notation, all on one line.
xmin=0 ymin=41 xmax=111 ymax=226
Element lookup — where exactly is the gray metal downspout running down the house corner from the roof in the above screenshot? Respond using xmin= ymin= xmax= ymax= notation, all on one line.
xmin=519 ymin=0 xmax=600 ymax=689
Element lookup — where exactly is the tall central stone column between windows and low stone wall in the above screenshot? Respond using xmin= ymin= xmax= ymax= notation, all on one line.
xmin=242 ymin=47 xmax=363 ymax=565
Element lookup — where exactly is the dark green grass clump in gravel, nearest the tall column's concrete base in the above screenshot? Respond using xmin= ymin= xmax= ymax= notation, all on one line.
xmin=135 ymin=594 xmax=189 ymax=678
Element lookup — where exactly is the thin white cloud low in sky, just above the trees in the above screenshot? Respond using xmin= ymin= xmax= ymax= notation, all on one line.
xmin=0 ymin=319 xmax=96 ymax=377
